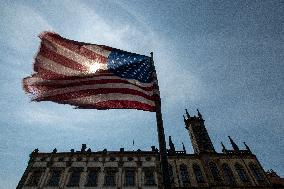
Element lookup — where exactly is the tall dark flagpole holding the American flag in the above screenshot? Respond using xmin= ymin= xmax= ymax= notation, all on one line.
xmin=150 ymin=52 xmax=171 ymax=189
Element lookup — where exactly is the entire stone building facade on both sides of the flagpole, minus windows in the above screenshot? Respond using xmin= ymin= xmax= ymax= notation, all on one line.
xmin=18 ymin=152 xmax=271 ymax=189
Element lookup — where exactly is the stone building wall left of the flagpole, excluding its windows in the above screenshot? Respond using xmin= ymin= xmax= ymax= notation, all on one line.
xmin=17 ymin=153 xmax=161 ymax=189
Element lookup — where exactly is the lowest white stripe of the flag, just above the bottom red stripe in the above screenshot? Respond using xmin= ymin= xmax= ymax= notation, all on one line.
xmin=64 ymin=93 xmax=155 ymax=106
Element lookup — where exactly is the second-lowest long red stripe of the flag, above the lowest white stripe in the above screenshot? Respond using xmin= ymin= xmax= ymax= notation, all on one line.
xmin=35 ymin=88 xmax=157 ymax=101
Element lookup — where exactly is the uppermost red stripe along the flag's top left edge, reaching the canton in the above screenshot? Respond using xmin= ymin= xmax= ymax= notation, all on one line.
xmin=40 ymin=32 xmax=107 ymax=63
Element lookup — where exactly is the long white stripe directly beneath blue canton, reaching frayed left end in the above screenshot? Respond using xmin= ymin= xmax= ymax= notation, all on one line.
xmin=25 ymin=73 xmax=157 ymax=87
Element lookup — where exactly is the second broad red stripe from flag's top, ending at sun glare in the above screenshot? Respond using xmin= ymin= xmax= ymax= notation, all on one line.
xmin=38 ymin=43 xmax=87 ymax=71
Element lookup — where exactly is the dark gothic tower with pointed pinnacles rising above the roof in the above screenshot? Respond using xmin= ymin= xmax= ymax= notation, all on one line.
xmin=183 ymin=109 xmax=216 ymax=154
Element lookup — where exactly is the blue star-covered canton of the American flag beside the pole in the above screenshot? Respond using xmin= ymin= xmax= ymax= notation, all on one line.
xmin=108 ymin=50 xmax=154 ymax=83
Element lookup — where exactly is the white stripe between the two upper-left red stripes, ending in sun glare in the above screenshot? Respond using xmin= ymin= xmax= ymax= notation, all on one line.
xmin=42 ymin=39 xmax=107 ymax=69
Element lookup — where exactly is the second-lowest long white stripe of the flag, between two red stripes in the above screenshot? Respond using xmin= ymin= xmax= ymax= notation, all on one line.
xmin=35 ymin=83 xmax=159 ymax=98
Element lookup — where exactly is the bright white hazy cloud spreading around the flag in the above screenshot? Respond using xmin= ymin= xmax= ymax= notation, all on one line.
xmin=1 ymin=1 xmax=201 ymax=131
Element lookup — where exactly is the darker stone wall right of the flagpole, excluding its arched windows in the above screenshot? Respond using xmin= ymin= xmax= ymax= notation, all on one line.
xmin=166 ymin=154 xmax=271 ymax=188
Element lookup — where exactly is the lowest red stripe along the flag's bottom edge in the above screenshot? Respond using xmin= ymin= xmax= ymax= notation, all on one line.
xmin=73 ymin=100 xmax=156 ymax=112
